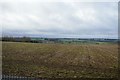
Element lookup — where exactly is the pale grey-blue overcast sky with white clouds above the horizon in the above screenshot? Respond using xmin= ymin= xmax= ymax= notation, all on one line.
xmin=0 ymin=2 xmax=118 ymax=38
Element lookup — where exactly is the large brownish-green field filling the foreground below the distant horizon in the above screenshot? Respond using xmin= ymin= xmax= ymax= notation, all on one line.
xmin=2 ymin=42 xmax=118 ymax=78
